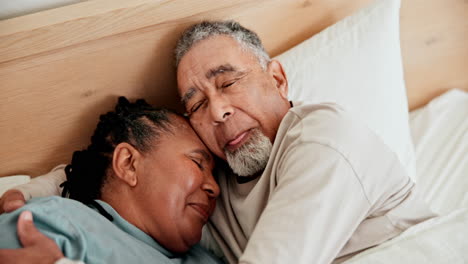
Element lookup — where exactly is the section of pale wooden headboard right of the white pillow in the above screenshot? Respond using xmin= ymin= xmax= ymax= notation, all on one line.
xmin=400 ymin=0 xmax=468 ymax=109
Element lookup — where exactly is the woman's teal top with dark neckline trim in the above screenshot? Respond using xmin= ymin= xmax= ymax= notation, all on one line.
xmin=0 ymin=196 xmax=222 ymax=264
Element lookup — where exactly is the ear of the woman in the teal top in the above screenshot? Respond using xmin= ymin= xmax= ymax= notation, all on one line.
xmin=112 ymin=143 xmax=141 ymax=187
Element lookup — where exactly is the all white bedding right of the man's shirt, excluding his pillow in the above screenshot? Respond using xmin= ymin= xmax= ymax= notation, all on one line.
xmin=345 ymin=90 xmax=468 ymax=264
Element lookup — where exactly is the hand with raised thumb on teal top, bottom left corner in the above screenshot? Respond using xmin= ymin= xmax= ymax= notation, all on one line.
xmin=0 ymin=211 xmax=63 ymax=264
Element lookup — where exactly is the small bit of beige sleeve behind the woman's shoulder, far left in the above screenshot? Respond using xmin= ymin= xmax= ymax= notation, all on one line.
xmin=14 ymin=164 xmax=66 ymax=201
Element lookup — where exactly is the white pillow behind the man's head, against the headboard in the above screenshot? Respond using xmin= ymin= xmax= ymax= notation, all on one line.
xmin=277 ymin=0 xmax=415 ymax=179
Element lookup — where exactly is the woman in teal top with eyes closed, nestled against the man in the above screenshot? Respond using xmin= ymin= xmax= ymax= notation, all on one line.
xmin=0 ymin=97 xmax=220 ymax=263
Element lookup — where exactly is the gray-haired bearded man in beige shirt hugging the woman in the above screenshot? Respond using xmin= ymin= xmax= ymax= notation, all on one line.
xmin=0 ymin=21 xmax=434 ymax=263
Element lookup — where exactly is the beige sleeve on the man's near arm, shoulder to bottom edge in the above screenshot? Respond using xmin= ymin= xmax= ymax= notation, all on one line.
xmin=240 ymin=142 xmax=370 ymax=263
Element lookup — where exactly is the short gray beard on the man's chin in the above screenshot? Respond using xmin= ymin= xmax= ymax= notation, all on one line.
xmin=224 ymin=129 xmax=273 ymax=176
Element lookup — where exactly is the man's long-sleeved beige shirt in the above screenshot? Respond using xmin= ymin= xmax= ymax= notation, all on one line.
xmin=209 ymin=103 xmax=434 ymax=264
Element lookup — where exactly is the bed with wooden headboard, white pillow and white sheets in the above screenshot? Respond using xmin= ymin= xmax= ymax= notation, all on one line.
xmin=0 ymin=0 xmax=468 ymax=263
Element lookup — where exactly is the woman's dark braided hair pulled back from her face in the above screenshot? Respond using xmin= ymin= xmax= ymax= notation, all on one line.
xmin=61 ymin=97 xmax=175 ymax=219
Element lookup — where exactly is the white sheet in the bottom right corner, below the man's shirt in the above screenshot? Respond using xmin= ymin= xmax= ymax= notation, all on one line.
xmin=345 ymin=209 xmax=468 ymax=264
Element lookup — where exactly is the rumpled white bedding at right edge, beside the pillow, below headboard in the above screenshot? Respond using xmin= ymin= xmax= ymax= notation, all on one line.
xmin=410 ymin=89 xmax=468 ymax=214
